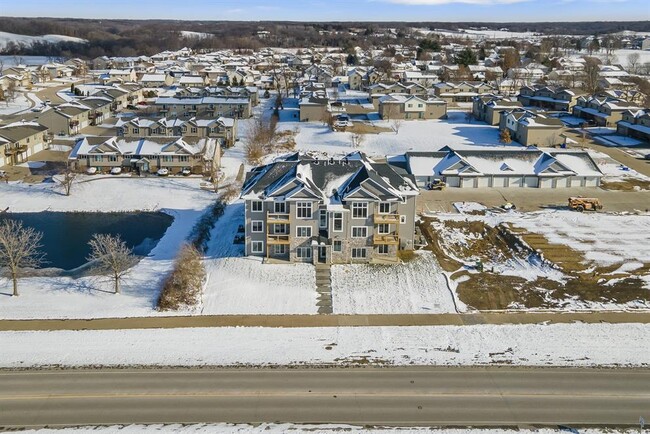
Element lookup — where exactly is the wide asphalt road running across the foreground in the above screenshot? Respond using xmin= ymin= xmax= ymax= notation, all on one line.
xmin=0 ymin=368 xmax=650 ymax=429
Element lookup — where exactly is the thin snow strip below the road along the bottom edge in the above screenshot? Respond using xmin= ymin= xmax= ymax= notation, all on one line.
xmin=16 ymin=423 xmax=638 ymax=434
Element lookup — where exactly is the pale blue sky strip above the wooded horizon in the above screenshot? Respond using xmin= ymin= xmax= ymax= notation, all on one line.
xmin=0 ymin=0 xmax=650 ymax=22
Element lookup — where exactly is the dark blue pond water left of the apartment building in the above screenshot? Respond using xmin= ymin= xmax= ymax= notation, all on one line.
xmin=0 ymin=211 xmax=174 ymax=270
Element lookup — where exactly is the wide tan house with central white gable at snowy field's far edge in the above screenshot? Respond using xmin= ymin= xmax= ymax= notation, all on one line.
xmin=379 ymin=94 xmax=447 ymax=120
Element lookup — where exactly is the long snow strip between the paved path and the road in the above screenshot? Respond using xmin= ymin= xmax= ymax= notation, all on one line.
xmin=0 ymin=323 xmax=650 ymax=368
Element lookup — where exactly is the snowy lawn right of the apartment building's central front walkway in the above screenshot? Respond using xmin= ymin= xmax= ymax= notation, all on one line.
xmin=332 ymin=251 xmax=454 ymax=314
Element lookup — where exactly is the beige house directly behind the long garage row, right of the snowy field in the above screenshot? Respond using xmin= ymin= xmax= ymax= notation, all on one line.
xmin=499 ymin=109 xmax=564 ymax=146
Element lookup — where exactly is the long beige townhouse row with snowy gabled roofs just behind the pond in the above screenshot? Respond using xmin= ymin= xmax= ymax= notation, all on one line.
xmin=68 ymin=136 xmax=221 ymax=175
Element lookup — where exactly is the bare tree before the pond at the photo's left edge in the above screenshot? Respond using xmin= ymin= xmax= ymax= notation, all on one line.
xmin=0 ymin=220 xmax=44 ymax=296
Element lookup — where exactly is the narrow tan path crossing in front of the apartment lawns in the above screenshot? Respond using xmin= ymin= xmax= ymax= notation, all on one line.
xmin=0 ymin=311 xmax=650 ymax=332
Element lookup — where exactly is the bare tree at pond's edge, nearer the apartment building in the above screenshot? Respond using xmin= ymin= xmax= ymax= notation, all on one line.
xmin=88 ymin=234 xmax=136 ymax=294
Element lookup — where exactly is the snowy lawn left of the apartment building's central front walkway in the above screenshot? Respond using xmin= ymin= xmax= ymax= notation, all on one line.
xmin=201 ymin=202 xmax=317 ymax=315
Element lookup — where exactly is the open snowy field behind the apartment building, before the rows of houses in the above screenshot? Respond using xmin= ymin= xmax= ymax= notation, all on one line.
xmin=278 ymin=111 xmax=521 ymax=156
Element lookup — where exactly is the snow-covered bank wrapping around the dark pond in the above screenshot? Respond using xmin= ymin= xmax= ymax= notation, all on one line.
xmin=0 ymin=176 xmax=215 ymax=318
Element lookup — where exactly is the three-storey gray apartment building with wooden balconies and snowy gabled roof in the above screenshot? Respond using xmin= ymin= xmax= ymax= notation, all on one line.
xmin=242 ymin=152 xmax=418 ymax=264
